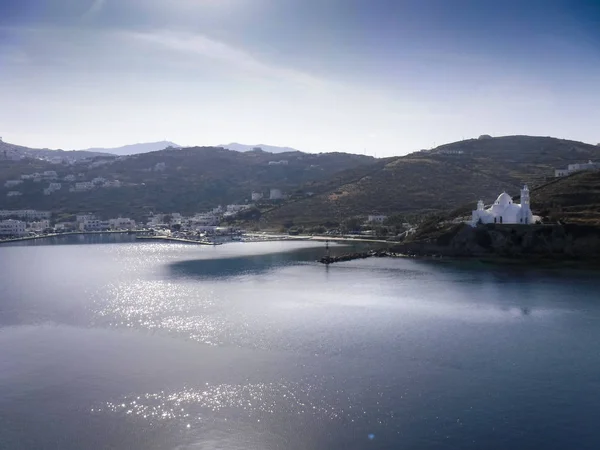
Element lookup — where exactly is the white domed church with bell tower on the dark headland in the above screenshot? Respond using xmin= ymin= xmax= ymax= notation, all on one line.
xmin=471 ymin=185 xmax=534 ymax=226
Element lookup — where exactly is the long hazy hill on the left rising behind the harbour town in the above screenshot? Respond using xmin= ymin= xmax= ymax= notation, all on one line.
xmin=0 ymin=147 xmax=376 ymax=218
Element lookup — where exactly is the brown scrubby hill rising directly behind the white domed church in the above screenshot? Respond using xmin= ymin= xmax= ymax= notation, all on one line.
xmin=265 ymin=136 xmax=600 ymax=225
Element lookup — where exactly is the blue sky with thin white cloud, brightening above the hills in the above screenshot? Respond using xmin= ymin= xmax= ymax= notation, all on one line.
xmin=0 ymin=0 xmax=600 ymax=157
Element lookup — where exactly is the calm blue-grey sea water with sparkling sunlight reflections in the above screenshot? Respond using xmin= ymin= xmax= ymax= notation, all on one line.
xmin=0 ymin=236 xmax=600 ymax=450
